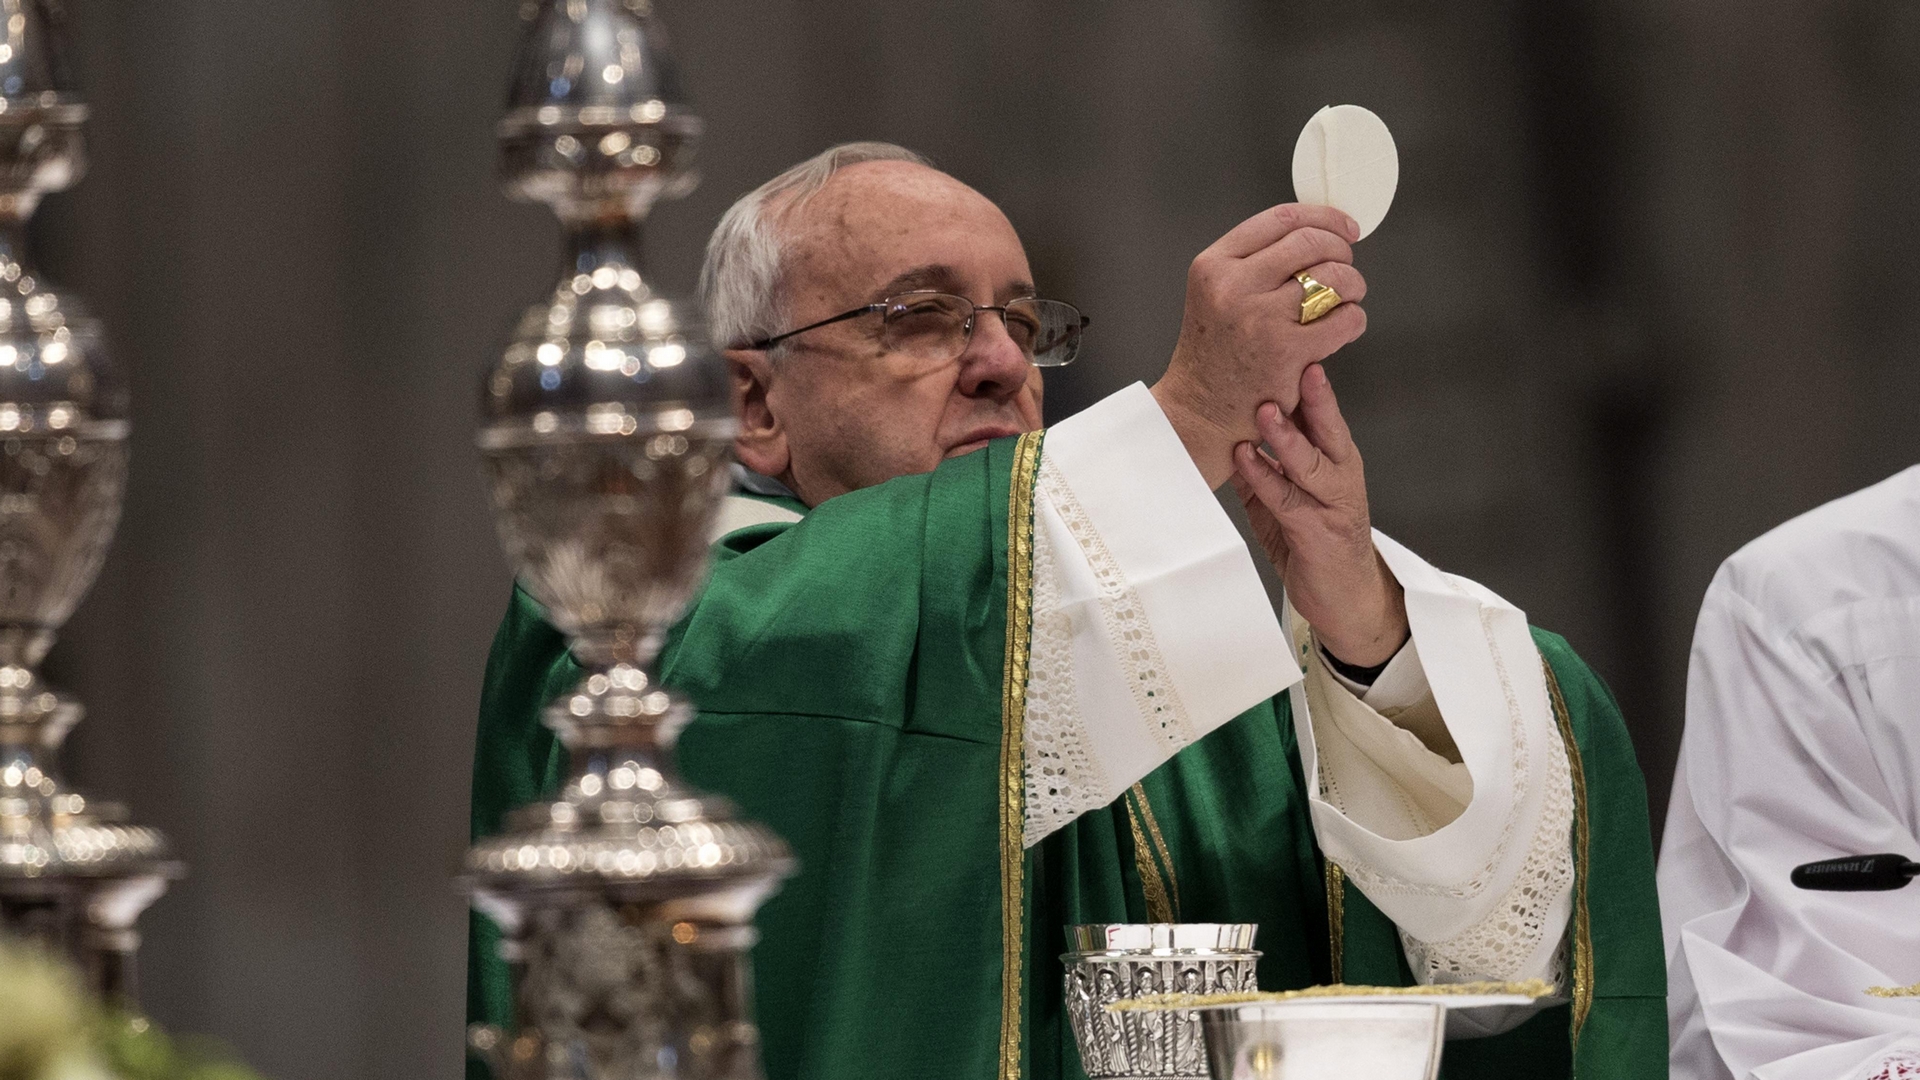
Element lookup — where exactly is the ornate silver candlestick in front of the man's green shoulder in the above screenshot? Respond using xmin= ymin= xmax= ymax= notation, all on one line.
xmin=463 ymin=0 xmax=793 ymax=1080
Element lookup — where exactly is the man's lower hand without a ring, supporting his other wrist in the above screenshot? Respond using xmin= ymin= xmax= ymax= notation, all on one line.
xmin=1233 ymin=361 xmax=1407 ymax=667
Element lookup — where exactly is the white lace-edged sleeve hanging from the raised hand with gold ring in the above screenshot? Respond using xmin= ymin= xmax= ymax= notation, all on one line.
xmin=1025 ymin=382 xmax=1300 ymax=847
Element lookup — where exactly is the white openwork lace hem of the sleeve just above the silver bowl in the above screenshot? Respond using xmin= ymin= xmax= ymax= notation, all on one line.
xmin=1400 ymin=699 xmax=1572 ymax=984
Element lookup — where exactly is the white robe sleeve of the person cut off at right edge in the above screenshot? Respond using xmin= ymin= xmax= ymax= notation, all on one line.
xmin=1659 ymin=569 xmax=1920 ymax=1080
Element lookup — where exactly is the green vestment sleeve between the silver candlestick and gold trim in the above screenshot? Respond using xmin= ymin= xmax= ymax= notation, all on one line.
xmin=662 ymin=442 xmax=1012 ymax=1080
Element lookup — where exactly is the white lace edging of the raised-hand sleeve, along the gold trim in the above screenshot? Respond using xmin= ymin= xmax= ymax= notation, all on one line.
xmin=1021 ymin=499 xmax=1110 ymax=847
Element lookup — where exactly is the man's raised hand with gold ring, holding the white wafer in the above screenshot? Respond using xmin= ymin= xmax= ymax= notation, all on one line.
xmin=1154 ymin=202 xmax=1367 ymax=488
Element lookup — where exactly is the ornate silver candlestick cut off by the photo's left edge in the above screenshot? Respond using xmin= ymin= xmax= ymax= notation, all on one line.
xmin=0 ymin=0 xmax=180 ymax=1005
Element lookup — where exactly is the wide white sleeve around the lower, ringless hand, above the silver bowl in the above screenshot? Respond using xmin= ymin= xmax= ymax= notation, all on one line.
xmin=1290 ymin=532 xmax=1572 ymax=982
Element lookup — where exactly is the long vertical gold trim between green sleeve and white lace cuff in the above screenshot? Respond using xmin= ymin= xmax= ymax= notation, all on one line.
xmin=998 ymin=430 xmax=1044 ymax=1080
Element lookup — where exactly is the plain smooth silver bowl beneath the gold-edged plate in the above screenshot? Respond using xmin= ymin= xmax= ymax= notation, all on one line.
xmin=1198 ymin=999 xmax=1446 ymax=1080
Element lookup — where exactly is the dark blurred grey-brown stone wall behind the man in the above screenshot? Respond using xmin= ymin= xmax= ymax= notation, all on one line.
xmin=36 ymin=0 xmax=1920 ymax=1080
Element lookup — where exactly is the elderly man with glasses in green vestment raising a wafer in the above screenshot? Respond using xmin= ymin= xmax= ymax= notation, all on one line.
xmin=470 ymin=144 xmax=1667 ymax=1080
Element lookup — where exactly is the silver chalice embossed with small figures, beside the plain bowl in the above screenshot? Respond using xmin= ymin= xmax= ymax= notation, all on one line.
xmin=1060 ymin=922 xmax=1260 ymax=1080
